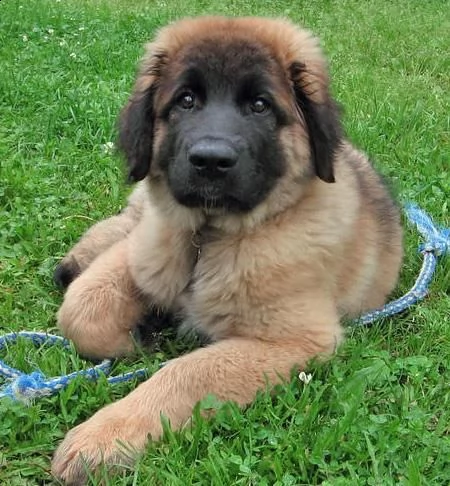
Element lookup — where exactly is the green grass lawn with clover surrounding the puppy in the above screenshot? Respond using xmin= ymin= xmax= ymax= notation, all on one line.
xmin=0 ymin=0 xmax=450 ymax=486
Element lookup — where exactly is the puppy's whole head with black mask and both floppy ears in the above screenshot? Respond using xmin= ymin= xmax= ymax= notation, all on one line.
xmin=120 ymin=17 xmax=341 ymax=213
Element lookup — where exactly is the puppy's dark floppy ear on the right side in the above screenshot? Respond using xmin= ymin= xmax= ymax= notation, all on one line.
xmin=290 ymin=62 xmax=342 ymax=182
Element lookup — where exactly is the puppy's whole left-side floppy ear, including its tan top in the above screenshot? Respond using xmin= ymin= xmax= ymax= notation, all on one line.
xmin=119 ymin=49 xmax=165 ymax=182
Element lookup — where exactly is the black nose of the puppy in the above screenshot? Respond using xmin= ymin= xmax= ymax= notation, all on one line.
xmin=188 ymin=140 xmax=238 ymax=178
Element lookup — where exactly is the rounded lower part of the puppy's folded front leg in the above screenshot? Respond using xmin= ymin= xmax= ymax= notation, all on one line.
xmin=58 ymin=239 xmax=145 ymax=358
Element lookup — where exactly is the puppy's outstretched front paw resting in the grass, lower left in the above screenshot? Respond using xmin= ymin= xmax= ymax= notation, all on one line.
xmin=52 ymin=402 xmax=154 ymax=486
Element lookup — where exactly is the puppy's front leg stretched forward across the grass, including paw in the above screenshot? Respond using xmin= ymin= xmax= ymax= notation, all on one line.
xmin=52 ymin=331 xmax=335 ymax=484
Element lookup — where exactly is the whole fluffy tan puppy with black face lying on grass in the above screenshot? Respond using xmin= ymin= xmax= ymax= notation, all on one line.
xmin=52 ymin=17 xmax=402 ymax=484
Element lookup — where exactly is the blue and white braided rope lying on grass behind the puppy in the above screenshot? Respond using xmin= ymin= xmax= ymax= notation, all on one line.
xmin=0 ymin=204 xmax=450 ymax=404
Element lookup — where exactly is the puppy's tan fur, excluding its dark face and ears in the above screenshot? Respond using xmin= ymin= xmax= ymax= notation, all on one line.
xmin=52 ymin=18 xmax=402 ymax=484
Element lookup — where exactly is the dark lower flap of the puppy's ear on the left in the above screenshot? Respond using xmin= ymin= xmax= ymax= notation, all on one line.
xmin=119 ymin=85 xmax=155 ymax=182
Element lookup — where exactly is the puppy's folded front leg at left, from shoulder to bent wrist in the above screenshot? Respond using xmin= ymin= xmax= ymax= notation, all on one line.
xmin=58 ymin=208 xmax=195 ymax=358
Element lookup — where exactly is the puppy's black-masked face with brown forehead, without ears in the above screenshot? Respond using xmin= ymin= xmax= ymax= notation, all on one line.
xmin=154 ymin=41 xmax=290 ymax=212
